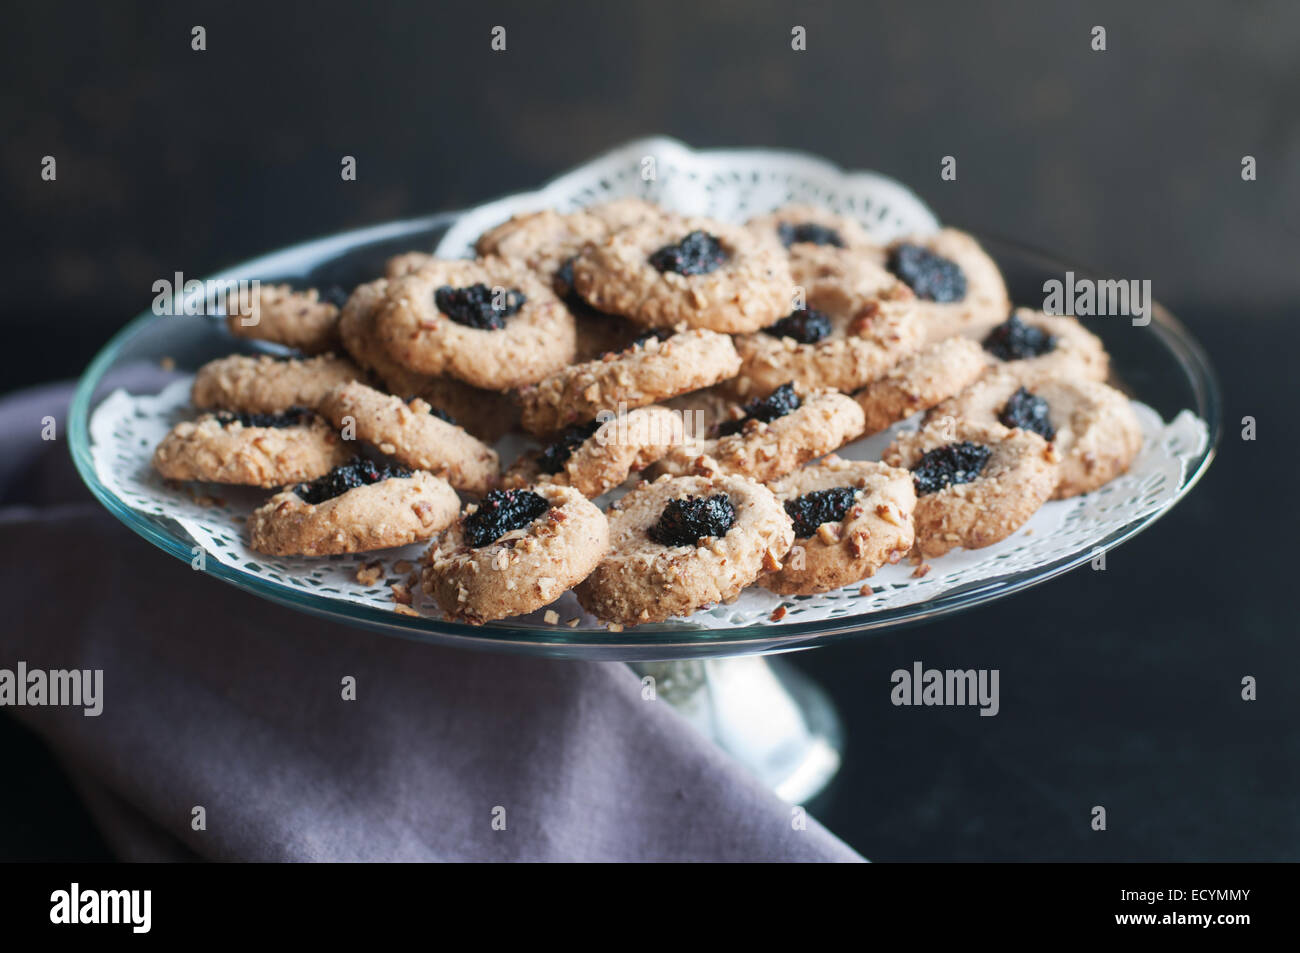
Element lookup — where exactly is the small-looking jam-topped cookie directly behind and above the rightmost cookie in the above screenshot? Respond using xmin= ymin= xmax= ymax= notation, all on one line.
xmin=980 ymin=308 xmax=1110 ymax=381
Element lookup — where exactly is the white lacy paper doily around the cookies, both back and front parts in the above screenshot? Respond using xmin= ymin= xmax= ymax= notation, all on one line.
xmin=90 ymin=138 xmax=1208 ymax=629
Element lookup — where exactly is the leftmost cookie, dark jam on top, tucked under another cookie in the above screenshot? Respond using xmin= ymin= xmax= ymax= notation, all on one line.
xmin=153 ymin=407 xmax=351 ymax=488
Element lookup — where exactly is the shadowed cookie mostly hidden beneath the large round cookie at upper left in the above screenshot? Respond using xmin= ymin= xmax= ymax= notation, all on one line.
xmin=338 ymin=273 xmax=519 ymax=442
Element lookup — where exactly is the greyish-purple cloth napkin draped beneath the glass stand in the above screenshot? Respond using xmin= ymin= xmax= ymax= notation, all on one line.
xmin=0 ymin=387 xmax=861 ymax=861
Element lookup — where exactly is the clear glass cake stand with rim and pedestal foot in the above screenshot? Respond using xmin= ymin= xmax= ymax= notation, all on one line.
xmin=68 ymin=213 xmax=1221 ymax=802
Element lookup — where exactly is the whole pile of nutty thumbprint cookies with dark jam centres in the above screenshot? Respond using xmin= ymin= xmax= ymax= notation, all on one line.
xmin=153 ymin=199 xmax=1141 ymax=628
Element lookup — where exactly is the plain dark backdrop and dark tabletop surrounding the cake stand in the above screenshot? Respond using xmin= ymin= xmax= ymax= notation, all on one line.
xmin=0 ymin=0 xmax=1300 ymax=859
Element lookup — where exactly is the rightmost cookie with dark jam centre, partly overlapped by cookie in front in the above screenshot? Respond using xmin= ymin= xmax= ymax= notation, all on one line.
xmin=926 ymin=367 xmax=1143 ymax=499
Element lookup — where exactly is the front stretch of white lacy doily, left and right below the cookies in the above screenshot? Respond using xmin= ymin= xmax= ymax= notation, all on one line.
xmin=90 ymin=378 xmax=1208 ymax=629
